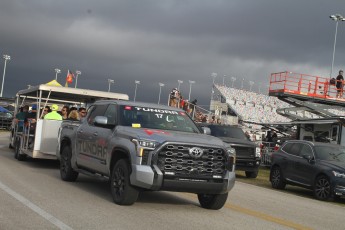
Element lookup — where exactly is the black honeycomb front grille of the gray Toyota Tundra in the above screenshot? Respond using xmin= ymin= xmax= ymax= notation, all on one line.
xmin=157 ymin=144 xmax=227 ymax=177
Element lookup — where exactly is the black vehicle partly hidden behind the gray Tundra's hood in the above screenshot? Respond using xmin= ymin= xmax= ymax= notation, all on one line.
xmin=198 ymin=123 xmax=261 ymax=178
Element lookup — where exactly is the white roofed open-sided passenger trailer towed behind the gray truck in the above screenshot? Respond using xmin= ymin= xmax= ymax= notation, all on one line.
xmin=9 ymin=84 xmax=129 ymax=160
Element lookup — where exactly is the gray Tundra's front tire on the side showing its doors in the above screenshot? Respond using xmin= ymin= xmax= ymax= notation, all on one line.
xmin=110 ymin=159 xmax=139 ymax=205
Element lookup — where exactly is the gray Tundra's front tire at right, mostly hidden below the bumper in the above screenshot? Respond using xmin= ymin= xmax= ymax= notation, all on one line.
xmin=198 ymin=193 xmax=228 ymax=210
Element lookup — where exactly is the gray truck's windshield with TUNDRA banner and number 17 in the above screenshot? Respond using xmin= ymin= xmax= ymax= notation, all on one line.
xmin=119 ymin=105 xmax=199 ymax=133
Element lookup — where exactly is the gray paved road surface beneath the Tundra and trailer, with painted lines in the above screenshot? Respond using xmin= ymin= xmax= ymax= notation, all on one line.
xmin=0 ymin=132 xmax=345 ymax=229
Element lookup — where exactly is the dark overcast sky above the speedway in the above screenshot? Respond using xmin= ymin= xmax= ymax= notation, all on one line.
xmin=0 ymin=0 xmax=345 ymax=108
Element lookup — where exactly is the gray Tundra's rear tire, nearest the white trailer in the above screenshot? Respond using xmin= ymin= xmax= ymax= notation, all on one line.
xmin=60 ymin=145 xmax=79 ymax=182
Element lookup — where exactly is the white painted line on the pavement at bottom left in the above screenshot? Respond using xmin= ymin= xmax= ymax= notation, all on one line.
xmin=0 ymin=182 xmax=73 ymax=230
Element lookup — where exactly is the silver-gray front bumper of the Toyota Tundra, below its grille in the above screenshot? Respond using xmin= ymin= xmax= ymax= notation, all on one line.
xmin=130 ymin=165 xmax=236 ymax=194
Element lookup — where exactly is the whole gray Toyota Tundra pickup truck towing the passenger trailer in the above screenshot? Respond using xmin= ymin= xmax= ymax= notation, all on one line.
xmin=56 ymin=100 xmax=236 ymax=210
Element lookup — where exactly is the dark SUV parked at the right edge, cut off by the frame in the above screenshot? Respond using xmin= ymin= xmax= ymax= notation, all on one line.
xmin=270 ymin=140 xmax=345 ymax=200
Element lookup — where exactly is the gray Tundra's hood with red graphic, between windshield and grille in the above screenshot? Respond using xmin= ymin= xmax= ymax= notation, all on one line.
xmin=117 ymin=126 xmax=226 ymax=147
